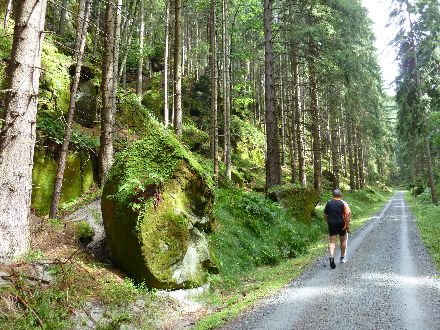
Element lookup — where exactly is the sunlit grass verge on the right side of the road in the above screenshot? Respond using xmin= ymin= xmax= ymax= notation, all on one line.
xmin=405 ymin=192 xmax=440 ymax=271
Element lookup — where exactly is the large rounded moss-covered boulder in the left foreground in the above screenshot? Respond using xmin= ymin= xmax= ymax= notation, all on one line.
xmin=102 ymin=123 xmax=214 ymax=289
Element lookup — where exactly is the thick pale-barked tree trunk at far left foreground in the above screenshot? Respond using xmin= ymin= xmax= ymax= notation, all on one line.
xmin=0 ymin=0 xmax=47 ymax=262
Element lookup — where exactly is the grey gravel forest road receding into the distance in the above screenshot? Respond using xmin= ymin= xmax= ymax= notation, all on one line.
xmin=226 ymin=192 xmax=440 ymax=330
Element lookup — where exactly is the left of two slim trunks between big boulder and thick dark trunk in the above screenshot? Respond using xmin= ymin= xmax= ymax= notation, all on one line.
xmin=209 ymin=0 xmax=218 ymax=185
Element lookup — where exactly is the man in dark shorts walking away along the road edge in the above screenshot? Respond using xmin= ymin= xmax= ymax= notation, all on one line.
xmin=324 ymin=189 xmax=351 ymax=269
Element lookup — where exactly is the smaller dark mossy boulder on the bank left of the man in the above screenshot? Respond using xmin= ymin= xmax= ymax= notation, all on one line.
xmin=269 ymin=184 xmax=319 ymax=223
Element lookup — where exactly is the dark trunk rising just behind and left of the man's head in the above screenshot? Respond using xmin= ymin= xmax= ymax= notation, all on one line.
xmin=308 ymin=44 xmax=321 ymax=191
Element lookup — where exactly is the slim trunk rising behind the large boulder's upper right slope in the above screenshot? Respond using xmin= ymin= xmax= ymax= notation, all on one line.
xmin=174 ymin=0 xmax=182 ymax=136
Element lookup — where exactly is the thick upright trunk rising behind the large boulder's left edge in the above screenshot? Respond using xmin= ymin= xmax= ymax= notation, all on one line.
xmin=99 ymin=0 xmax=122 ymax=182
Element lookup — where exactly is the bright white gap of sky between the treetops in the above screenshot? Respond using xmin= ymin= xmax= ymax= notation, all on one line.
xmin=362 ymin=0 xmax=397 ymax=94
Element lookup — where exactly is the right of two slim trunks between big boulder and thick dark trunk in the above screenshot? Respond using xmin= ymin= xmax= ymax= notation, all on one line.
xmin=222 ymin=0 xmax=232 ymax=180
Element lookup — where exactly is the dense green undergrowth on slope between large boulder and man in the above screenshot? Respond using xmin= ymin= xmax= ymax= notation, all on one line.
xmin=210 ymin=190 xmax=323 ymax=282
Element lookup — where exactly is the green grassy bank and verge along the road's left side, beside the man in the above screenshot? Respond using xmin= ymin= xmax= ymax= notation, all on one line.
xmin=196 ymin=188 xmax=393 ymax=329
